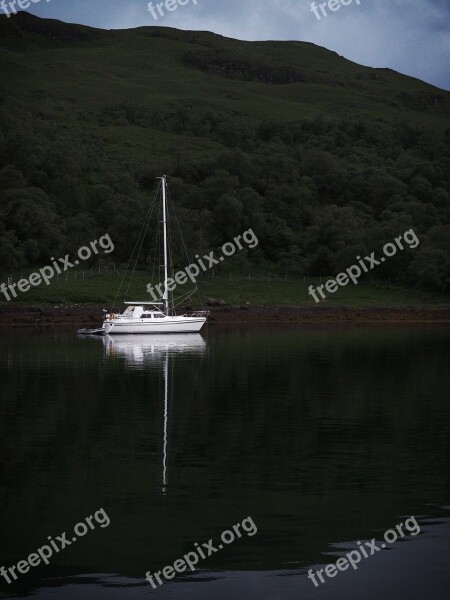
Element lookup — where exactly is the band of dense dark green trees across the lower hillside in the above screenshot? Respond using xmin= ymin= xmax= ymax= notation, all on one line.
xmin=0 ymin=103 xmax=450 ymax=290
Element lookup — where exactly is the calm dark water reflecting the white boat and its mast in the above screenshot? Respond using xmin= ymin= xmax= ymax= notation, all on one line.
xmin=0 ymin=325 xmax=450 ymax=600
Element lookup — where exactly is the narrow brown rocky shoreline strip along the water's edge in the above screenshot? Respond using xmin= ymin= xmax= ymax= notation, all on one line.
xmin=0 ymin=306 xmax=450 ymax=327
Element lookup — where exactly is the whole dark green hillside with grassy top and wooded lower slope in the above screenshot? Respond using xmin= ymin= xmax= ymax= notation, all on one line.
xmin=0 ymin=13 xmax=450 ymax=291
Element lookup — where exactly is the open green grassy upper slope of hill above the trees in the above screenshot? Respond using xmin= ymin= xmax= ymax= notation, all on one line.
xmin=0 ymin=13 xmax=450 ymax=168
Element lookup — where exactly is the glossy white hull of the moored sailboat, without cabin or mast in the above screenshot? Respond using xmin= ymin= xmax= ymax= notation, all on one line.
xmin=103 ymin=316 xmax=206 ymax=335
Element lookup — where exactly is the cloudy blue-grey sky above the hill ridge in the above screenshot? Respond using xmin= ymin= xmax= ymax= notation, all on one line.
xmin=19 ymin=0 xmax=450 ymax=89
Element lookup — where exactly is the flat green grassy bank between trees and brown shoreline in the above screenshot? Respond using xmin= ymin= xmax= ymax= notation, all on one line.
xmin=0 ymin=269 xmax=450 ymax=308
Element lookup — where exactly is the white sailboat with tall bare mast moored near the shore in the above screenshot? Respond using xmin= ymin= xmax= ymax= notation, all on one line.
xmin=78 ymin=175 xmax=209 ymax=335
